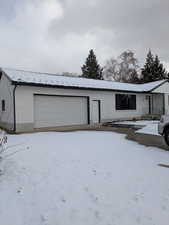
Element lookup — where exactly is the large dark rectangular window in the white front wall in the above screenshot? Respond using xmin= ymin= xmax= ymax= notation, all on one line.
xmin=116 ymin=94 xmax=136 ymax=110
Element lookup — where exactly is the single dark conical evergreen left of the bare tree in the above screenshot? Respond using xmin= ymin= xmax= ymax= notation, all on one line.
xmin=82 ymin=49 xmax=103 ymax=80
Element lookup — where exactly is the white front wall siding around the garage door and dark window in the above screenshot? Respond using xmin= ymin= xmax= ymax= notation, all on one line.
xmin=16 ymin=86 xmax=149 ymax=131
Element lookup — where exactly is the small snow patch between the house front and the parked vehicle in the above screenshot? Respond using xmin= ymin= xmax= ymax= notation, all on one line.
xmin=115 ymin=120 xmax=159 ymax=135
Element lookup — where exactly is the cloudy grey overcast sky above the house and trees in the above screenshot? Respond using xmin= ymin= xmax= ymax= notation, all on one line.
xmin=0 ymin=0 xmax=169 ymax=73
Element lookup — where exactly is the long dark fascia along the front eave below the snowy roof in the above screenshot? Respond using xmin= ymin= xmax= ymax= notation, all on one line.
xmin=12 ymin=81 xmax=150 ymax=94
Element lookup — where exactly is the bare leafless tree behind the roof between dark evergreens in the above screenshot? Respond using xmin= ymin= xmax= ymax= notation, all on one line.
xmin=103 ymin=50 xmax=140 ymax=83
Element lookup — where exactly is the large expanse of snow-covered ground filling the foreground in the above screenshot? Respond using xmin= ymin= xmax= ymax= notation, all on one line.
xmin=0 ymin=131 xmax=169 ymax=225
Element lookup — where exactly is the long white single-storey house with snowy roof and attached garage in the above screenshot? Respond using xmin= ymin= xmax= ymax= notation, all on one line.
xmin=0 ymin=68 xmax=169 ymax=132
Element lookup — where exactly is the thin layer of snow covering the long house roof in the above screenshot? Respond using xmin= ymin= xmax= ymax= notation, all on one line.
xmin=1 ymin=68 xmax=166 ymax=92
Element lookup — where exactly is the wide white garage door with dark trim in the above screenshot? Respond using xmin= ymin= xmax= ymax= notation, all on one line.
xmin=34 ymin=95 xmax=88 ymax=128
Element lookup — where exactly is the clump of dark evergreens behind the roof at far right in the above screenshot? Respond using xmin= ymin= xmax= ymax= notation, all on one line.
xmin=142 ymin=50 xmax=168 ymax=83
